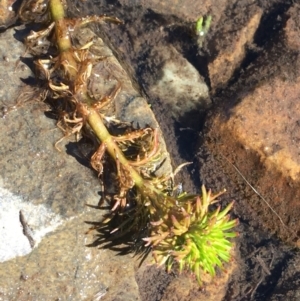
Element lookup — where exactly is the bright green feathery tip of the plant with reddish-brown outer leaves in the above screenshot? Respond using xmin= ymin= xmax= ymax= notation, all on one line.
xmin=144 ymin=186 xmax=237 ymax=282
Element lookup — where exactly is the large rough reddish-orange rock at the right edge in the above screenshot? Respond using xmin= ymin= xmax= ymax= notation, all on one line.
xmin=205 ymin=77 xmax=300 ymax=245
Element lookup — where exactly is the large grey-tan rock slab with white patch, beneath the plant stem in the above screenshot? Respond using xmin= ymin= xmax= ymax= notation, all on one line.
xmin=0 ymin=28 xmax=171 ymax=300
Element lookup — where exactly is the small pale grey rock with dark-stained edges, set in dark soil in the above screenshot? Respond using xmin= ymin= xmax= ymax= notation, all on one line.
xmin=149 ymin=46 xmax=211 ymax=120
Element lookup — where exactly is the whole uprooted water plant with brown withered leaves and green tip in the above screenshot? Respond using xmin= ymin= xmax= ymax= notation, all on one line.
xmin=19 ymin=0 xmax=237 ymax=282
